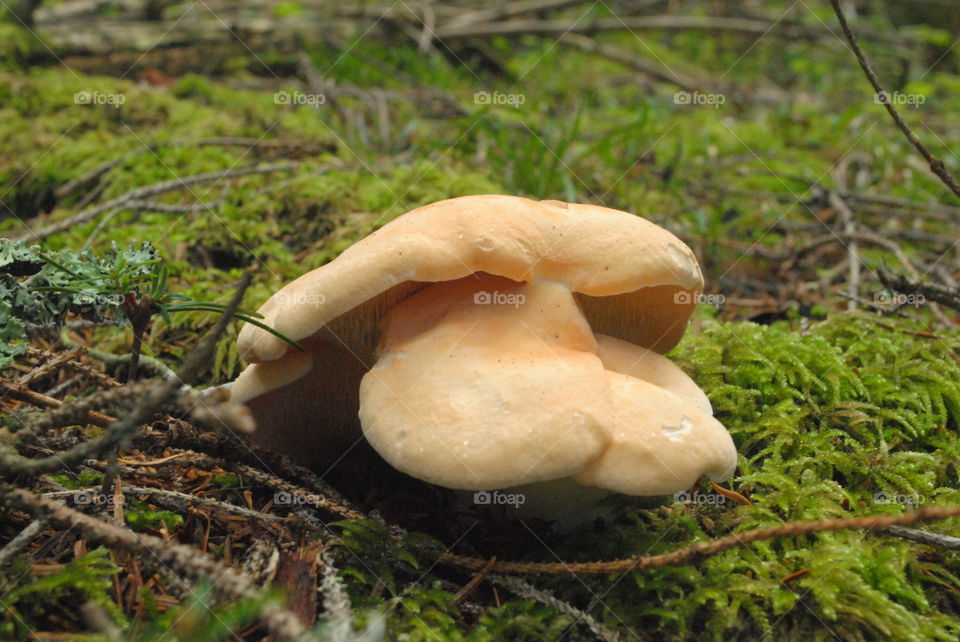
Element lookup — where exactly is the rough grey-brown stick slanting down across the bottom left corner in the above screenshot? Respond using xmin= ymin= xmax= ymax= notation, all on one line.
xmin=0 ymin=483 xmax=304 ymax=638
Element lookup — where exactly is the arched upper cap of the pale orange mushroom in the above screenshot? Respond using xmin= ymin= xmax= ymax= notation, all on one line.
xmin=238 ymin=195 xmax=703 ymax=363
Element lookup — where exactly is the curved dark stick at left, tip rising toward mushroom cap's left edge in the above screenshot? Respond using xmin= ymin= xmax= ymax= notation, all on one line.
xmin=0 ymin=272 xmax=253 ymax=475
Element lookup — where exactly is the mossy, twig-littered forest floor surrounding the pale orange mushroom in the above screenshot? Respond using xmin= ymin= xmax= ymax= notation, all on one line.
xmin=0 ymin=1 xmax=960 ymax=640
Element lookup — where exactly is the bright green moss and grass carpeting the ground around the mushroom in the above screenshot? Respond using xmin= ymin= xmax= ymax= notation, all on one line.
xmin=0 ymin=2 xmax=960 ymax=640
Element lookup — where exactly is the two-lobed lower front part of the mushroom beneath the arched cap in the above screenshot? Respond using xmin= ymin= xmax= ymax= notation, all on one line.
xmin=360 ymin=275 xmax=736 ymax=495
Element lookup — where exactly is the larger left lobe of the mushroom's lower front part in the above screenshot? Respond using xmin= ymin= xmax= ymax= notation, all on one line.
xmin=360 ymin=275 xmax=612 ymax=489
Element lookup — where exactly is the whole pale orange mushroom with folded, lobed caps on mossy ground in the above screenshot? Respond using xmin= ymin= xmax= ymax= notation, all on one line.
xmin=230 ymin=195 xmax=736 ymax=518
